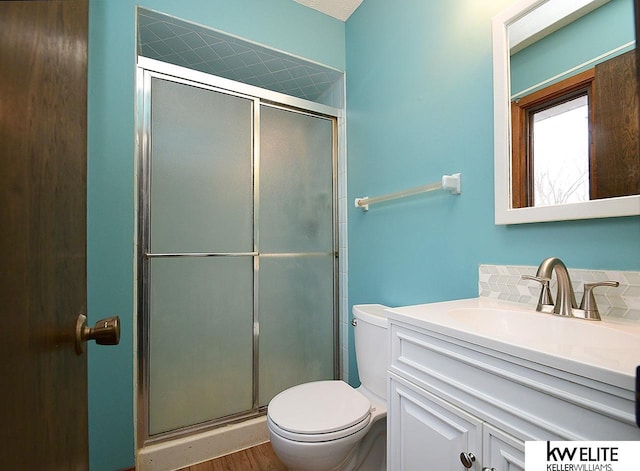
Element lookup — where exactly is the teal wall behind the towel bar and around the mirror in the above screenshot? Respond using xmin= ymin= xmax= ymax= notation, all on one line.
xmin=346 ymin=0 xmax=640 ymax=384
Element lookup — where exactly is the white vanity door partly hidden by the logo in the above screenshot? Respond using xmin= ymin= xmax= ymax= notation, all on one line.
xmin=482 ymin=423 xmax=524 ymax=471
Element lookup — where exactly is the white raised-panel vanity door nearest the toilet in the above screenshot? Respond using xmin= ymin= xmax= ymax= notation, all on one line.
xmin=387 ymin=375 xmax=482 ymax=471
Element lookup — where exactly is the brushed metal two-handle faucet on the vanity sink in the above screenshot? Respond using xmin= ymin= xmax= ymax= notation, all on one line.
xmin=522 ymin=257 xmax=620 ymax=321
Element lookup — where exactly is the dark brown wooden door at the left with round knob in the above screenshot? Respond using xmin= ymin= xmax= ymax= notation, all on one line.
xmin=0 ymin=0 xmax=88 ymax=470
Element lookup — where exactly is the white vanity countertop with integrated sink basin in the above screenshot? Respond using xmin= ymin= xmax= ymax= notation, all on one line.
xmin=389 ymin=298 xmax=640 ymax=390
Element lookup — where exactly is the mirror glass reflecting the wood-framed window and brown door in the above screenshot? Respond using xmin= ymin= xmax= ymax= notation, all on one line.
xmin=510 ymin=0 xmax=640 ymax=208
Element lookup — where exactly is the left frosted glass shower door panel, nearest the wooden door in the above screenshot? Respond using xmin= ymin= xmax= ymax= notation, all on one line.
xmin=147 ymin=78 xmax=255 ymax=435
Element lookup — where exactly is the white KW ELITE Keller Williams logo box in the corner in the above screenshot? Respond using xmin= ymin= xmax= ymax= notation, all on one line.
xmin=525 ymin=441 xmax=640 ymax=471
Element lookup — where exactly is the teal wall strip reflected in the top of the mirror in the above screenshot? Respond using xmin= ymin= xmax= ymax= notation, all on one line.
xmin=511 ymin=0 xmax=635 ymax=95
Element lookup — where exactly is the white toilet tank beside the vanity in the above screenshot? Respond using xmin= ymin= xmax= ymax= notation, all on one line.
xmin=353 ymin=304 xmax=389 ymax=401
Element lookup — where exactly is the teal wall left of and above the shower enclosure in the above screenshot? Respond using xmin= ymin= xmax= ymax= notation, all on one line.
xmin=87 ymin=0 xmax=345 ymax=471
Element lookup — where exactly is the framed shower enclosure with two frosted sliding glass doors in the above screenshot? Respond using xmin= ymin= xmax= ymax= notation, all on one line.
xmin=137 ymin=58 xmax=340 ymax=446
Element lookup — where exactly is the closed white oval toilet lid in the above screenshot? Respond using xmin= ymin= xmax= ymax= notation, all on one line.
xmin=268 ymin=381 xmax=371 ymax=434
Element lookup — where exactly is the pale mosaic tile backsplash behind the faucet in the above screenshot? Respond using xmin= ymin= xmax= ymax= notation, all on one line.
xmin=478 ymin=265 xmax=640 ymax=322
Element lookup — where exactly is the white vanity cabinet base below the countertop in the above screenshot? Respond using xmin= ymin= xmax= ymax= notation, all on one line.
xmin=387 ymin=311 xmax=640 ymax=471
